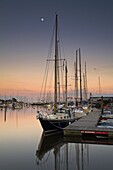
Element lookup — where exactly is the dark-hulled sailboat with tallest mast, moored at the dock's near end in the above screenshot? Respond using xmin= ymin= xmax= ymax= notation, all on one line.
xmin=37 ymin=15 xmax=75 ymax=134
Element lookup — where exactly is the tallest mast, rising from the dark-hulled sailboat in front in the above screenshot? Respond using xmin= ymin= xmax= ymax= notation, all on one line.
xmin=54 ymin=15 xmax=58 ymax=112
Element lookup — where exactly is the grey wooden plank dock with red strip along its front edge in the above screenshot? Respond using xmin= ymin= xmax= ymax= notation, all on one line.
xmin=63 ymin=109 xmax=113 ymax=138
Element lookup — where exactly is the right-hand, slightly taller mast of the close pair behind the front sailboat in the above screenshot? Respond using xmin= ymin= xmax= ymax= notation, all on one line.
xmin=79 ymin=48 xmax=82 ymax=104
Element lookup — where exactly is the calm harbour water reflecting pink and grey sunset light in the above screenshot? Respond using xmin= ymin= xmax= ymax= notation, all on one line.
xmin=0 ymin=107 xmax=113 ymax=170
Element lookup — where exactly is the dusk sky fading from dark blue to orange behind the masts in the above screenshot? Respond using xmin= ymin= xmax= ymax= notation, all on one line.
xmin=0 ymin=0 xmax=113 ymax=101
